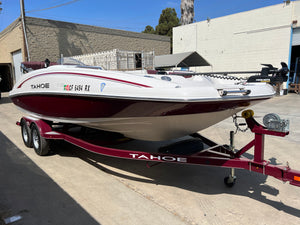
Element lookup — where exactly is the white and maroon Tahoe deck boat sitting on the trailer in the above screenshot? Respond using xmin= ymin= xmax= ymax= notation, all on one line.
xmin=10 ymin=62 xmax=274 ymax=141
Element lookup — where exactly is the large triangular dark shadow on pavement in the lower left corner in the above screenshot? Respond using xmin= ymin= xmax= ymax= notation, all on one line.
xmin=0 ymin=132 xmax=99 ymax=225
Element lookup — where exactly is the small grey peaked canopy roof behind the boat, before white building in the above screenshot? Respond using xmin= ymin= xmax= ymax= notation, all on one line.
xmin=154 ymin=52 xmax=210 ymax=68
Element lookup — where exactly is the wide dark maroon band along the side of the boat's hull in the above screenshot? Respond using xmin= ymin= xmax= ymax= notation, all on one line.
xmin=12 ymin=95 xmax=263 ymax=118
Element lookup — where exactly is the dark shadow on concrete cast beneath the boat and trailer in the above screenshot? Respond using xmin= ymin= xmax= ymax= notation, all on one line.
xmin=55 ymin=142 xmax=300 ymax=218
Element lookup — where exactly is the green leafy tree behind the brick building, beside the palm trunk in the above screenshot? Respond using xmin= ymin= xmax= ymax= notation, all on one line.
xmin=143 ymin=8 xmax=180 ymax=37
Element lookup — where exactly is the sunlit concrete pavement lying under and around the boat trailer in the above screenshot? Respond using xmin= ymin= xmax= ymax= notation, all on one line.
xmin=0 ymin=93 xmax=300 ymax=225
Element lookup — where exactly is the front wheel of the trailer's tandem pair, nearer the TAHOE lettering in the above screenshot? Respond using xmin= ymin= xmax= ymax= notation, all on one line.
xmin=31 ymin=124 xmax=50 ymax=156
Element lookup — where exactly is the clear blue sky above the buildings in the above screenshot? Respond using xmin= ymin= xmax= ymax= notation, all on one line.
xmin=0 ymin=0 xmax=290 ymax=32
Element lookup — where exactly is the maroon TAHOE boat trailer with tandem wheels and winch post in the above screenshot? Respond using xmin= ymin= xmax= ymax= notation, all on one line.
xmin=17 ymin=110 xmax=300 ymax=187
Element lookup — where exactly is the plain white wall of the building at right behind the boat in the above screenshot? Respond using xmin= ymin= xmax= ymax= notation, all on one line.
xmin=173 ymin=2 xmax=300 ymax=72
